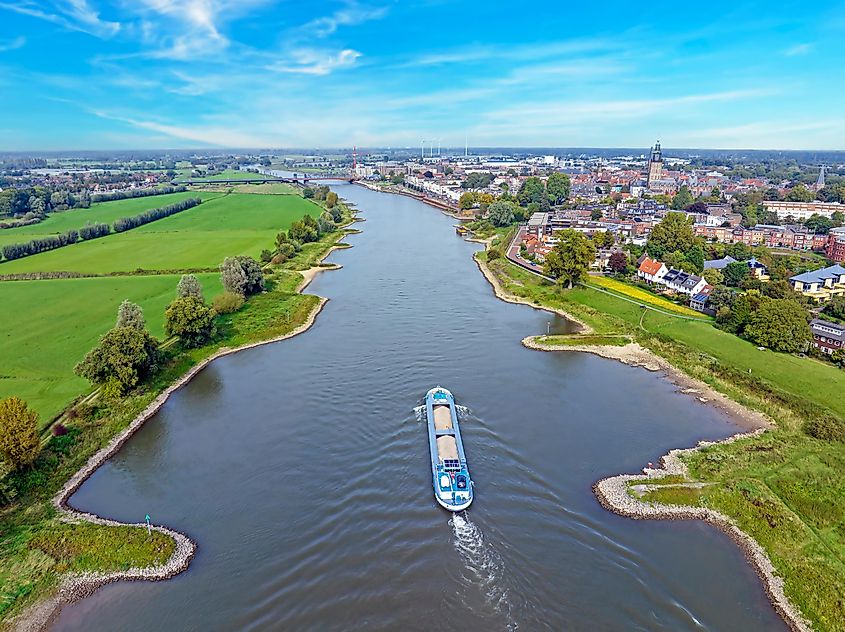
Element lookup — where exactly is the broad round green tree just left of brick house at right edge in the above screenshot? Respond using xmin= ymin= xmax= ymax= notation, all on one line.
xmin=745 ymin=298 xmax=813 ymax=353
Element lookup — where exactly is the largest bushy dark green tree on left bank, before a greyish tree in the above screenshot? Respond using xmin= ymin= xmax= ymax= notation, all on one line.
xmin=74 ymin=327 xmax=158 ymax=397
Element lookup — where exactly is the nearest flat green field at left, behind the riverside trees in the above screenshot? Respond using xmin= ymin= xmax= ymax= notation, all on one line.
xmin=0 ymin=273 xmax=221 ymax=424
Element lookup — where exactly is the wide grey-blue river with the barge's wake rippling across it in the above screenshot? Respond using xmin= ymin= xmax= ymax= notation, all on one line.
xmin=54 ymin=185 xmax=785 ymax=632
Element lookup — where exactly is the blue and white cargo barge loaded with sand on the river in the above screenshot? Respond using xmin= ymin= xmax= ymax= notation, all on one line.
xmin=425 ymin=386 xmax=473 ymax=511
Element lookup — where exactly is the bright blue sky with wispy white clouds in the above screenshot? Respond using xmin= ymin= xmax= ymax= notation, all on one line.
xmin=0 ymin=0 xmax=845 ymax=150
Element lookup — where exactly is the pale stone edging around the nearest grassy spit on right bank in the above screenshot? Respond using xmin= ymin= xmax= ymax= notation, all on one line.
xmin=593 ymin=429 xmax=812 ymax=632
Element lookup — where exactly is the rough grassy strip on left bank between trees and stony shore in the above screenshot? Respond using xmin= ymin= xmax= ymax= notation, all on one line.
xmin=0 ymin=196 xmax=351 ymax=628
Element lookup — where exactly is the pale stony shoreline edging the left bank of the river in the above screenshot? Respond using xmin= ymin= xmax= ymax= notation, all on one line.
xmin=10 ymin=239 xmax=351 ymax=632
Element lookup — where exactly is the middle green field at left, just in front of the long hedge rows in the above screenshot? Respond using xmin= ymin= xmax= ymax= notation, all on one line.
xmin=0 ymin=193 xmax=322 ymax=274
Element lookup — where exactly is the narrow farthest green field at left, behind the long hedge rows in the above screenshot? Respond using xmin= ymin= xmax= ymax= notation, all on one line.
xmin=0 ymin=191 xmax=222 ymax=247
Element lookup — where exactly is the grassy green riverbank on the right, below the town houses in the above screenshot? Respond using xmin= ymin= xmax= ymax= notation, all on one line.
xmin=478 ymin=253 xmax=845 ymax=631
